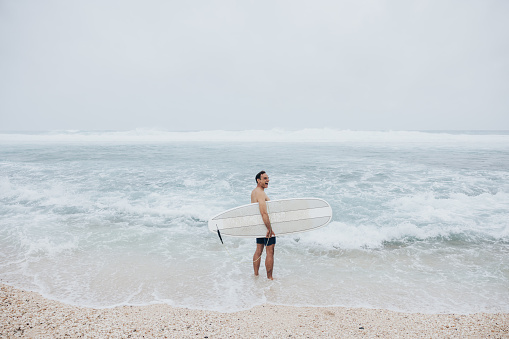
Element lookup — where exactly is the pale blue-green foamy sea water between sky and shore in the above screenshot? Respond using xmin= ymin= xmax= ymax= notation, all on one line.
xmin=0 ymin=130 xmax=509 ymax=313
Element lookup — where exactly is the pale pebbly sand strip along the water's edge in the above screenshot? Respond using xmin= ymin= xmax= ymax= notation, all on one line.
xmin=0 ymin=285 xmax=509 ymax=338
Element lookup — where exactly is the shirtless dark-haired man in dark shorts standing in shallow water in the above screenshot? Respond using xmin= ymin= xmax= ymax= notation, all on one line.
xmin=251 ymin=171 xmax=276 ymax=280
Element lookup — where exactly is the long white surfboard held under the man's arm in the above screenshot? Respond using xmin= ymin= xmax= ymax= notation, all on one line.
xmin=209 ymin=198 xmax=332 ymax=238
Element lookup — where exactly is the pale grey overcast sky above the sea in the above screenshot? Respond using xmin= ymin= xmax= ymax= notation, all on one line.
xmin=0 ymin=0 xmax=509 ymax=131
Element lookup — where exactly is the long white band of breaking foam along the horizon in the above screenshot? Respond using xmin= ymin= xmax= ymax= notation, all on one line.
xmin=0 ymin=128 xmax=509 ymax=146
